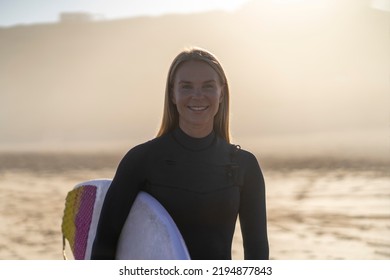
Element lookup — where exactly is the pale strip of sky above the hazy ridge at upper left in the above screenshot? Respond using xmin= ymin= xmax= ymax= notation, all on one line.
xmin=0 ymin=0 xmax=248 ymax=26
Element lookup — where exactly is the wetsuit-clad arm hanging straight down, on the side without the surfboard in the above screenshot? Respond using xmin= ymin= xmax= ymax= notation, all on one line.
xmin=239 ymin=152 xmax=269 ymax=259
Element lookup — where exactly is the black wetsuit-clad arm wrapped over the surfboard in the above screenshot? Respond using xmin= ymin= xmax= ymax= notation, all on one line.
xmin=91 ymin=146 xmax=145 ymax=260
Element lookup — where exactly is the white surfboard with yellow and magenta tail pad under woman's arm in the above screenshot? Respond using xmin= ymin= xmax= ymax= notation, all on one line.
xmin=62 ymin=179 xmax=190 ymax=260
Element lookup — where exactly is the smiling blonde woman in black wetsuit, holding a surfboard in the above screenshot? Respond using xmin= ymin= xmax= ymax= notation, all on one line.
xmin=92 ymin=48 xmax=268 ymax=259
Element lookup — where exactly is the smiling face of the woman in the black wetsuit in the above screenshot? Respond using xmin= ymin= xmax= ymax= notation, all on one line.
xmin=172 ymin=60 xmax=223 ymax=138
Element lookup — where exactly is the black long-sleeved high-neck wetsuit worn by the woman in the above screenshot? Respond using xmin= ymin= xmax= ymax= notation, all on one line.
xmin=92 ymin=128 xmax=269 ymax=260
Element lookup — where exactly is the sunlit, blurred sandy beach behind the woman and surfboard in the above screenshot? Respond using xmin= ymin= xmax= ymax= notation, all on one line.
xmin=0 ymin=153 xmax=390 ymax=260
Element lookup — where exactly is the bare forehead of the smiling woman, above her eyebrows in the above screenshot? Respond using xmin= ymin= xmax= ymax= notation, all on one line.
xmin=174 ymin=60 xmax=219 ymax=82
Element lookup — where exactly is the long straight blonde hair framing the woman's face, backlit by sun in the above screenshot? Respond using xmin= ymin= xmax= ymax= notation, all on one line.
xmin=157 ymin=47 xmax=230 ymax=143
